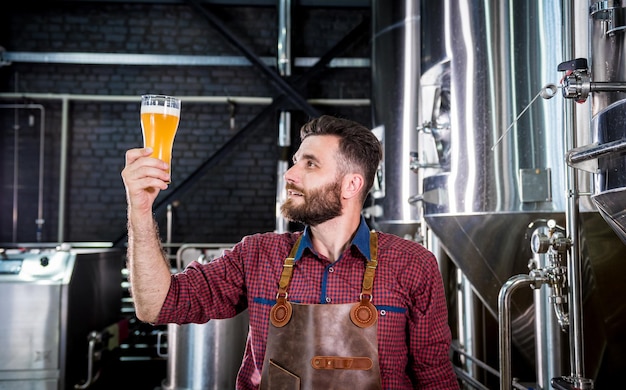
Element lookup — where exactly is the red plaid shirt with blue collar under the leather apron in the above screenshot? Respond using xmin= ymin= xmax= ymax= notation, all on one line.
xmin=158 ymin=220 xmax=459 ymax=389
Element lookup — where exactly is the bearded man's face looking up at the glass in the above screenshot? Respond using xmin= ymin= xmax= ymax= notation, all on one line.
xmin=281 ymin=135 xmax=342 ymax=226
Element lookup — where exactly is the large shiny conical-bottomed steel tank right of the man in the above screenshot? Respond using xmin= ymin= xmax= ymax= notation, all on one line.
xmin=424 ymin=0 xmax=565 ymax=330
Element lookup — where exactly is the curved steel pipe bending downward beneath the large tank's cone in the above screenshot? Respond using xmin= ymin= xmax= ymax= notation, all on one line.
xmin=498 ymin=275 xmax=534 ymax=390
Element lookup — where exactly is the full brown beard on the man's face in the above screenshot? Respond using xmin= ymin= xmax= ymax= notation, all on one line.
xmin=280 ymin=181 xmax=341 ymax=226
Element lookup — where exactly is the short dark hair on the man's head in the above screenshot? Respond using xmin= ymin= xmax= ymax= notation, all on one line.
xmin=300 ymin=115 xmax=383 ymax=201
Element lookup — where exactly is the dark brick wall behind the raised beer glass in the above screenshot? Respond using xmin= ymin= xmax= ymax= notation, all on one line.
xmin=0 ymin=2 xmax=371 ymax=242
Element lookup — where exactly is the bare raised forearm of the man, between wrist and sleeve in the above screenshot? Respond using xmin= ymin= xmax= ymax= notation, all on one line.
xmin=127 ymin=210 xmax=171 ymax=323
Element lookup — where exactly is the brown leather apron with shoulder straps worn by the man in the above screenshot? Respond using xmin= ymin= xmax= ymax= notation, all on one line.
xmin=261 ymin=232 xmax=382 ymax=390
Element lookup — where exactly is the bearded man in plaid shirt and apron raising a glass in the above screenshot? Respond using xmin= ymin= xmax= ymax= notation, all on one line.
xmin=122 ymin=116 xmax=459 ymax=390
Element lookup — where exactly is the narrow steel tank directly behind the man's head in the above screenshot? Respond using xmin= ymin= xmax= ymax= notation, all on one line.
xmin=372 ymin=0 xmax=421 ymax=236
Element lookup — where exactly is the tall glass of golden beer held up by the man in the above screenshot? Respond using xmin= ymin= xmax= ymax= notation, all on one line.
xmin=141 ymin=95 xmax=180 ymax=181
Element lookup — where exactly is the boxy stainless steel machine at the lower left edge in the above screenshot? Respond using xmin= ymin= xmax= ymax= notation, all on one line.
xmin=0 ymin=244 xmax=123 ymax=390
